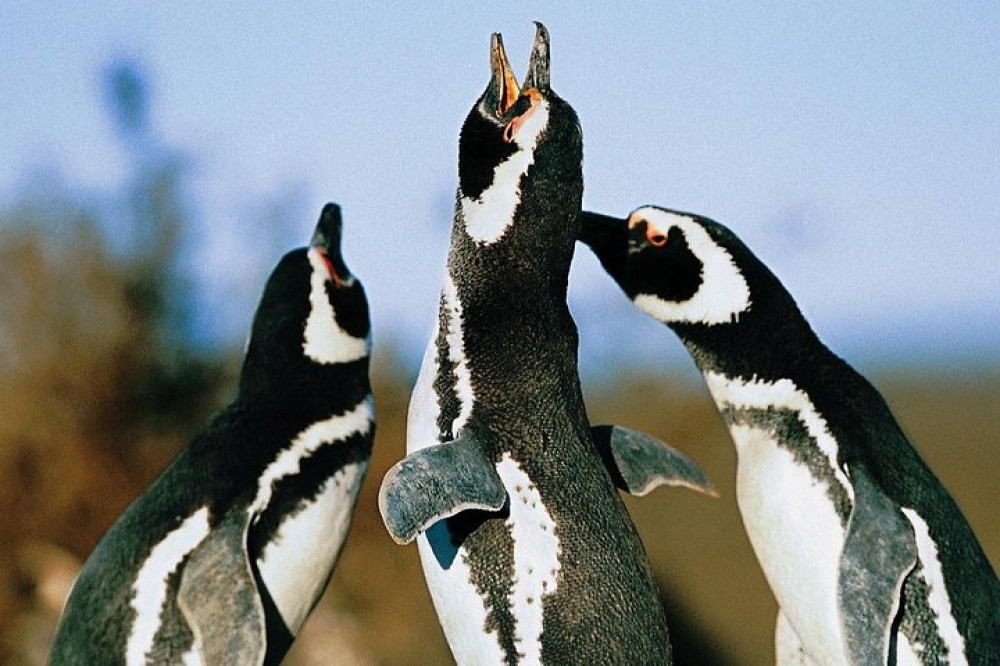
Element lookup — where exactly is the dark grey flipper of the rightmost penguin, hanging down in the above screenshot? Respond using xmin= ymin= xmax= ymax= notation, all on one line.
xmin=837 ymin=464 xmax=917 ymax=664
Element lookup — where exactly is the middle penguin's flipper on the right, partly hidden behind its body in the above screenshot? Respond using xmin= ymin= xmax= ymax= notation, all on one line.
xmin=590 ymin=425 xmax=719 ymax=497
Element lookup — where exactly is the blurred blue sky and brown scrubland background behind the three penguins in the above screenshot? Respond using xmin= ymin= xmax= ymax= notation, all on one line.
xmin=0 ymin=5 xmax=1000 ymax=664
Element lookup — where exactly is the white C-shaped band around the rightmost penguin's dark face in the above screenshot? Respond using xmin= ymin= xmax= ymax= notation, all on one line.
xmin=629 ymin=207 xmax=751 ymax=325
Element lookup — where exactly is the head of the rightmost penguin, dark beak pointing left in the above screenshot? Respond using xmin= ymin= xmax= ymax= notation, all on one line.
xmin=580 ymin=206 xmax=756 ymax=326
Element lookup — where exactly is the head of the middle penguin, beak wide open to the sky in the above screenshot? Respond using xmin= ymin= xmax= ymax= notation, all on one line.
xmin=458 ymin=23 xmax=583 ymax=247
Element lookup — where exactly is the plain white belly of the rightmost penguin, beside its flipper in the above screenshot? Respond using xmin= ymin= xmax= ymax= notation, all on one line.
xmin=730 ymin=425 xmax=845 ymax=664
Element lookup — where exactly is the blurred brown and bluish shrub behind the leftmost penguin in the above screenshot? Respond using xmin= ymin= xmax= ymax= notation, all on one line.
xmin=0 ymin=64 xmax=229 ymax=663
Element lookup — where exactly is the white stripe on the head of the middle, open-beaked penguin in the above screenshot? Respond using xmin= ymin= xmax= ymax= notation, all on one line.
xmin=459 ymin=100 xmax=549 ymax=245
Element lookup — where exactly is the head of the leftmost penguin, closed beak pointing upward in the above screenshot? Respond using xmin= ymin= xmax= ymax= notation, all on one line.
xmin=240 ymin=203 xmax=371 ymax=393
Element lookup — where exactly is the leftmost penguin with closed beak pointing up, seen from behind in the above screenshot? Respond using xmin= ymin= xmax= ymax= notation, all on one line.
xmin=51 ymin=204 xmax=375 ymax=666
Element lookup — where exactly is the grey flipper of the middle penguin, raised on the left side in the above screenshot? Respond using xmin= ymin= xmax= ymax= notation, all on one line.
xmin=378 ymin=433 xmax=507 ymax=544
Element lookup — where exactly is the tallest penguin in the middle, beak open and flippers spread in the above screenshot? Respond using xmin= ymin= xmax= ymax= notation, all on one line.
xmin=379 ymin=24 xmax=706 ymax=665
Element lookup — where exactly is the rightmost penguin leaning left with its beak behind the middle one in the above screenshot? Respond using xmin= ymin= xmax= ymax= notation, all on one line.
xmin=581 ymin=207 xmax=1000 ymax=665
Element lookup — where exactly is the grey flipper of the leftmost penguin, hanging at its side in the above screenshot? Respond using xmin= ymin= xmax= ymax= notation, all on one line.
xmin=177 ymin=510 xmax=267 ymax=664
